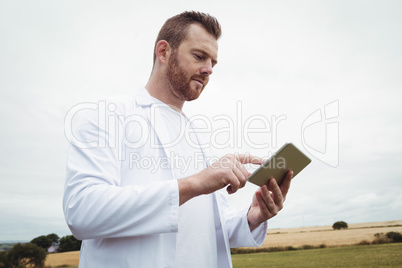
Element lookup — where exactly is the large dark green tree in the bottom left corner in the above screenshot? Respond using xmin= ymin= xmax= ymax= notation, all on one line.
xmin=0 ymin=243 xmax=46 ymax=268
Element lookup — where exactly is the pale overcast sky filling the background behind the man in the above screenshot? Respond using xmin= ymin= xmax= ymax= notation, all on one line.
xmin=0 ymin=0 xmax=402 ymax=241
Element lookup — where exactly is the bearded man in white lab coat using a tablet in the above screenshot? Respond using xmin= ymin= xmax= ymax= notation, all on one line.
xmin=63 ymin=12 xmax=292 ymax=268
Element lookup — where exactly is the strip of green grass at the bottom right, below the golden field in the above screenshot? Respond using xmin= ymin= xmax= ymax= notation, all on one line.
xmin=232 ymin=243 xmax=402 ymax=268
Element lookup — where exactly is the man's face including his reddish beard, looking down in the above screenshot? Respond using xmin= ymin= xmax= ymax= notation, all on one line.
xmin=166 ymin=24 xmax=218 ymax=101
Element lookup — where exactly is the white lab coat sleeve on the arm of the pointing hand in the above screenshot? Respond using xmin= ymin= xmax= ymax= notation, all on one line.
xmin=63 ymin=103 xmax=179 ymax=240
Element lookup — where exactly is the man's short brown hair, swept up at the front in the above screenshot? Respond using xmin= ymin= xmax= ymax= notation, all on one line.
xmin=154 ymin=11 xmax=222 ymax=64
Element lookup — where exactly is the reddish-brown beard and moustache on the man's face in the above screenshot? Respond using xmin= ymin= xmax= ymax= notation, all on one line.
xmin=166 ymin=50 xmax=208 ymax=101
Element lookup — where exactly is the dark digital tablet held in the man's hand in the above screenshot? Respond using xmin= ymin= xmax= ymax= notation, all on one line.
xmin=248 ymin=143 xmax=311 ymax=186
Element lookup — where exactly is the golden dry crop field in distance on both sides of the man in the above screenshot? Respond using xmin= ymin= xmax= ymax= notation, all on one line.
xmin=45 ymin=220 xmax=402 ymax=267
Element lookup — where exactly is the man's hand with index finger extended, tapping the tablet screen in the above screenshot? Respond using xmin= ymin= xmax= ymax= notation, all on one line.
xmin=178 ymin=154 xmax=264 ymax=205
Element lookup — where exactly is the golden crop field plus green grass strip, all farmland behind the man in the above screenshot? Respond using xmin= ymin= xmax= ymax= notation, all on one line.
xmin=45 ymin=220 xmax=402 ymax=268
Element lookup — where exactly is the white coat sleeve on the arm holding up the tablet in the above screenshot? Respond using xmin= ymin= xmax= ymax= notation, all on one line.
xmin=218 ymin=191 xmax=268 ymax=248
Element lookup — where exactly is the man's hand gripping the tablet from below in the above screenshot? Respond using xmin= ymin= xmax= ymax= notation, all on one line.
xmin=247 ymin=171 xmax=293 ymax=231
